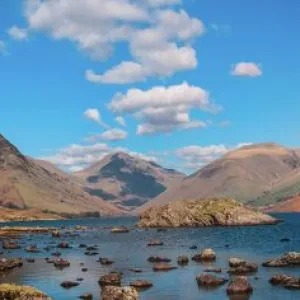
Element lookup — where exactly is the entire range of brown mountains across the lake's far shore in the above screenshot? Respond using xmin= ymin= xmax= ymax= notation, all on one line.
xmin=0 ymin=134 xmax=300 ymax=216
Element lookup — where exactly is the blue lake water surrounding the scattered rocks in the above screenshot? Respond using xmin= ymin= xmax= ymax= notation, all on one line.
xmin=0 ymin=214 xmax=300 ymax=300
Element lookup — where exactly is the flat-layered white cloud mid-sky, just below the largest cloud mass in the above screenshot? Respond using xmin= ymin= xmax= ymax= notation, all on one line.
xmin=109 ymin=82 xmax=218 ymax=135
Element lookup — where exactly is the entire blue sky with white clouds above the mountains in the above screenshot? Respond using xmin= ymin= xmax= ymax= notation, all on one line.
xmin=0 ymin=0 xmax=300 ymax=173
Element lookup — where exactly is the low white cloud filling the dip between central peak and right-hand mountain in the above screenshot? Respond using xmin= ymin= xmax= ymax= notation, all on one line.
xmin=175 ymin=143 xmax=252 ymax=170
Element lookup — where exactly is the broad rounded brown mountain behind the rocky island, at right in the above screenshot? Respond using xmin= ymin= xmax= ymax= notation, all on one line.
xmin=140 ymin=143 xmax=300 ymax=210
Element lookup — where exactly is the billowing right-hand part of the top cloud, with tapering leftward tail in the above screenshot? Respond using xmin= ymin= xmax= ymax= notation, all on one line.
xmin=86 ymin=9 xmax=204 ymax=84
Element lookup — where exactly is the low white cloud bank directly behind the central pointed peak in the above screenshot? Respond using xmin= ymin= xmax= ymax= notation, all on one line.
xmin=40 ymin=143 xmax=156 ymax=171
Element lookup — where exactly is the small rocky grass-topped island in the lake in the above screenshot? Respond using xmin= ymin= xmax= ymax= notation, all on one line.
xmin=138 ymin=198 xmax=279 ymax=228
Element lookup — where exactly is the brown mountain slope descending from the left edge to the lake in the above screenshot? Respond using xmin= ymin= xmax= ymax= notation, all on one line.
xmin=0 ymin=134 xmax=120 ymax=215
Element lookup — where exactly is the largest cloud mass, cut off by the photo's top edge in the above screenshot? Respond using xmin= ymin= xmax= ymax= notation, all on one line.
xmin=15 ymin=0 xmax=205 ymax=84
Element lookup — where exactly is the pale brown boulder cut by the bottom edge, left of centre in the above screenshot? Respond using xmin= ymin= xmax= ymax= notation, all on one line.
xmin=101 ymin=286 xmax=140 ymax=300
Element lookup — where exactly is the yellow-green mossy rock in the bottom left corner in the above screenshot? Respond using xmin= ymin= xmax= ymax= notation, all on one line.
xmin=0 ymin=283 xmax=51 ymax=300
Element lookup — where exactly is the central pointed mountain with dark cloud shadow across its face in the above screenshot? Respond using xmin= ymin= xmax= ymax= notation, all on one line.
xmin=74 ymin=152 xmax=184 ymax=210
